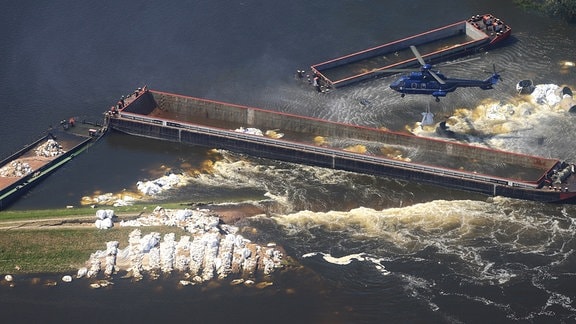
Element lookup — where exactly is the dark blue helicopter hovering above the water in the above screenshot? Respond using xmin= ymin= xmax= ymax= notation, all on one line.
xmin=386 ymin=46 xmax=502 ymax=102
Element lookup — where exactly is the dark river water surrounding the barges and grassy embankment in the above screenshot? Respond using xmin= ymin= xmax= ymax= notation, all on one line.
xmin=0 ymin=0 xmax=576 ymax=323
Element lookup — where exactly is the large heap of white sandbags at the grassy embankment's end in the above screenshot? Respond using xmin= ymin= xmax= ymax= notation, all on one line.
xmin=77 ymin=207 xmax=283 ymax=284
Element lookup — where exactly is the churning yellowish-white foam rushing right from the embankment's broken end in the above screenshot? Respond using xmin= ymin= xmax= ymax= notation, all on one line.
xmin=274 ymin=197 xmax=576 ymax=319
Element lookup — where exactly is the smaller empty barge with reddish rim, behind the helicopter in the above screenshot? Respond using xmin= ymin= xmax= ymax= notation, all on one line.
xmin=311 ymin=14 xmax=512 ymax=88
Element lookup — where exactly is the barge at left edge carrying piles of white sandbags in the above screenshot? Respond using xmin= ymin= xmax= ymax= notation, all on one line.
xmin=0 ymin=119 xmax=106 ymax=210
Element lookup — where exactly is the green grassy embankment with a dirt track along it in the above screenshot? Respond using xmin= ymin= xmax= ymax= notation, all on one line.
xmin=0 ymin=205 xmax=182 ymax=274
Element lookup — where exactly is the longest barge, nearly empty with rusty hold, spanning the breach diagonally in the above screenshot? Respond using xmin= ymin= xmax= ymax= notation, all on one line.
xmin=109 ymin=90 xmax=576 ymax=203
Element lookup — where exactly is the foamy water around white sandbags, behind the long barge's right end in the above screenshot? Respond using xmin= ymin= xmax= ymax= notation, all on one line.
xmin=408 ymin=84 xmax=576 ymax=156
